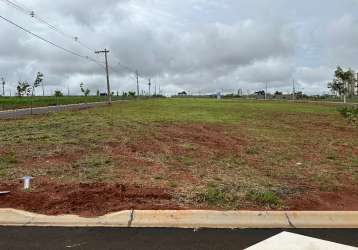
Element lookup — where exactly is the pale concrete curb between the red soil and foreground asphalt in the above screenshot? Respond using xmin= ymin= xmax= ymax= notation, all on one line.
xmin=0 ymin=209 xmax=358 ymax=229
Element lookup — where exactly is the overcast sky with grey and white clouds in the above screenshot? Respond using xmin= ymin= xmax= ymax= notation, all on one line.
xmin=0 ymin=0 xmax=358 ymax=94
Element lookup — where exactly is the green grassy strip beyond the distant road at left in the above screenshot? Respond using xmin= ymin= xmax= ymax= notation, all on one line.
xmin=0 ymin=96 xmax=128 ymax=110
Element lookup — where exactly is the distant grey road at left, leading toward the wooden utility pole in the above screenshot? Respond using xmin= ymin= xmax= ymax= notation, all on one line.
xmin=0 ymin=102 xmax=107 ymax=119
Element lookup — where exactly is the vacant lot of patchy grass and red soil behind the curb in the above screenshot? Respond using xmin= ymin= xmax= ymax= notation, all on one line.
xmin=0 ymin=99 xmax=358 ymax=216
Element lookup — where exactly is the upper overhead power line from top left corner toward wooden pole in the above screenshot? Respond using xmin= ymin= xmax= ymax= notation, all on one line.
xmin=1 ymin=0 xmax=95 ymax=52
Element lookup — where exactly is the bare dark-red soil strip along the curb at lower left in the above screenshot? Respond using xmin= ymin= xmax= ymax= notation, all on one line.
xmin=0 ymin=183 xmax=178 ymax=217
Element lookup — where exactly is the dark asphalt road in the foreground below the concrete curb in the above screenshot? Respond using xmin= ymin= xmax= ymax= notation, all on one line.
xmin=0 ymin=227 xmax=358 ymax=250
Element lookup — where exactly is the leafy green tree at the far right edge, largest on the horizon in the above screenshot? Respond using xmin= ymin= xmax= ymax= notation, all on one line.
xmin=328 ymin=66 xmax=356 ymax=102
